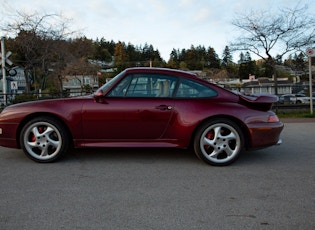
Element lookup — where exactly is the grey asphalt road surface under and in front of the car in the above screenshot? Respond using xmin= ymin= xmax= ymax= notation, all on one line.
xmin=0 ymin=122 xmax=315 ymax=230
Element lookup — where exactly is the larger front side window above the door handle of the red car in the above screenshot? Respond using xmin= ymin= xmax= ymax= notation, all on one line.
xmin=108 ymin=73 xmax=177 ymax=97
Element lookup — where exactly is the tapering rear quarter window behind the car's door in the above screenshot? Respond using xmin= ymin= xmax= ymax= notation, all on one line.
xmin=176 ymin=79 xmax=217 ymax=98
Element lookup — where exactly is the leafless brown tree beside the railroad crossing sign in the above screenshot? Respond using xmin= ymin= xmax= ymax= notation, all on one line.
xmin=1 ymin=11 xmax=74 ymax=92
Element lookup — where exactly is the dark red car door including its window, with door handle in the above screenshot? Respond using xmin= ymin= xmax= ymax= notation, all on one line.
xmin=82 ymin=74 xmax=176 ymax=141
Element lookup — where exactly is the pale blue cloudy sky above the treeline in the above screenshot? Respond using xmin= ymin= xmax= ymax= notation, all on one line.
xmin=0 ymin=0 xmax=315 ymax=61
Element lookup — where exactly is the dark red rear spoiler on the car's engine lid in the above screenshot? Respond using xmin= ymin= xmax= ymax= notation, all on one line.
xmin=239 ymin=94 xmax=279 ymax=111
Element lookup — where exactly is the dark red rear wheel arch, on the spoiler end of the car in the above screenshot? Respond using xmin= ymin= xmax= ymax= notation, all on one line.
xmin=190 ymin=114 xmax=250 ymax=149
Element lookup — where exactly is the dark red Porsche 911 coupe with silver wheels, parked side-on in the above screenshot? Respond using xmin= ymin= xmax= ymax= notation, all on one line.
xmin=0 ymin=68 xmax=283 ymax=165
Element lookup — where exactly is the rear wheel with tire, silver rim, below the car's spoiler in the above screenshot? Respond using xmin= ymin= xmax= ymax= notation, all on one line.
xmin=194 ymin=119 xmax=244 ymax=166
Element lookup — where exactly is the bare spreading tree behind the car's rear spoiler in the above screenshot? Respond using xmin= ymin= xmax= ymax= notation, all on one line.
xmin=230 ymin=6 xmax=315 ymax=94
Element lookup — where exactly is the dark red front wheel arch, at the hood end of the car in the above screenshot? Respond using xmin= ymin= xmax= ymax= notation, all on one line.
xmin=16 ymin=112 xmax=73 ymax=148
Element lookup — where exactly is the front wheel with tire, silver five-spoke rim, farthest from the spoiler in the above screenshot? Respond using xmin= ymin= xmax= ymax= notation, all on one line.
xmin=20 ymin=116 xmax=69 ymax=163
